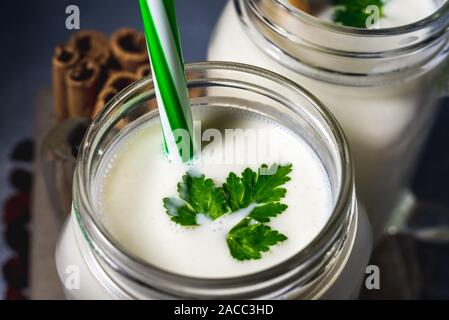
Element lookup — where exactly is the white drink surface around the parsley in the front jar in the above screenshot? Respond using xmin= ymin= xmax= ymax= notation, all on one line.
xmin=99 ymin=107 xmax=332 ymax=278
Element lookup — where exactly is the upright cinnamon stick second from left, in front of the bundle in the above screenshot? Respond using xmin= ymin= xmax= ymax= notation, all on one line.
xmin=66 ymin=58 xmax=101 ymax=117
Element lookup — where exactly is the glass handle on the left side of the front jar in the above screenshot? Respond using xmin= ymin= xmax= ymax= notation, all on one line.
xmin=39 ymin=118 xmax=87 ymax=224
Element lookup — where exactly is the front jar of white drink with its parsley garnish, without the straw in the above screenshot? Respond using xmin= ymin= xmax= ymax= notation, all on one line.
xmin=56 ymin=63 xmax=371 ymax=299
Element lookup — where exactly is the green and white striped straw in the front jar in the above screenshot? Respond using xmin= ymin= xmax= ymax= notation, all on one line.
xmin=139 ymin=0 xmax=194 ymax=162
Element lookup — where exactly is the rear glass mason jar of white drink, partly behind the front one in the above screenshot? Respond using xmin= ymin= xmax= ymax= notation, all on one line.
xmin=208 ymin=0 xmax=449 ymax=238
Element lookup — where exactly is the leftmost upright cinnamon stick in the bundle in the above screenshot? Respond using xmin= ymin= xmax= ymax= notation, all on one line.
xmin=52 ymin=45 xmax=80 ymax=122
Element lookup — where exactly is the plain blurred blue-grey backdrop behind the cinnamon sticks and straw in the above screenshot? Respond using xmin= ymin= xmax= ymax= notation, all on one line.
xmin=0 ymin=0 xmax=226 ymax=298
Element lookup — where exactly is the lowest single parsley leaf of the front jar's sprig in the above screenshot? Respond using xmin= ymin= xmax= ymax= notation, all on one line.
xmin=226 ymin=218 xmax=287 ymax=261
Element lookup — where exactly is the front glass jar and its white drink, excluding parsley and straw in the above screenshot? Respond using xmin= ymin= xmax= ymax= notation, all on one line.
xmin=56 ymin=63 xmax=372 ymax=299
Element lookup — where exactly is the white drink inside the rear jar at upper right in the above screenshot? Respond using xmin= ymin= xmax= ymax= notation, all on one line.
xmin=208 ymin=0 xmax=444 ymax=239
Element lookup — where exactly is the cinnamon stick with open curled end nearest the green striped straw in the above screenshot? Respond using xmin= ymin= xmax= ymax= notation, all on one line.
xmin=111 ymin=28 xmax=148 ymax=72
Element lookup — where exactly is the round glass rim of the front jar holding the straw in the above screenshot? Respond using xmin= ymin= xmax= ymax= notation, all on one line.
xmin=73 ymin=62 xmax=355 ymax=296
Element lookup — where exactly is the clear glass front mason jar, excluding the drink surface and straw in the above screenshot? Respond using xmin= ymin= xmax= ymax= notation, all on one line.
xmin=56 ymin=63 xmax=372 ymax=299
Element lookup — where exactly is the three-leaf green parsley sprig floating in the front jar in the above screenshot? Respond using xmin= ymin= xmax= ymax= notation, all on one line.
xmin=163 ymin=164 xmax=292 ymax=260
